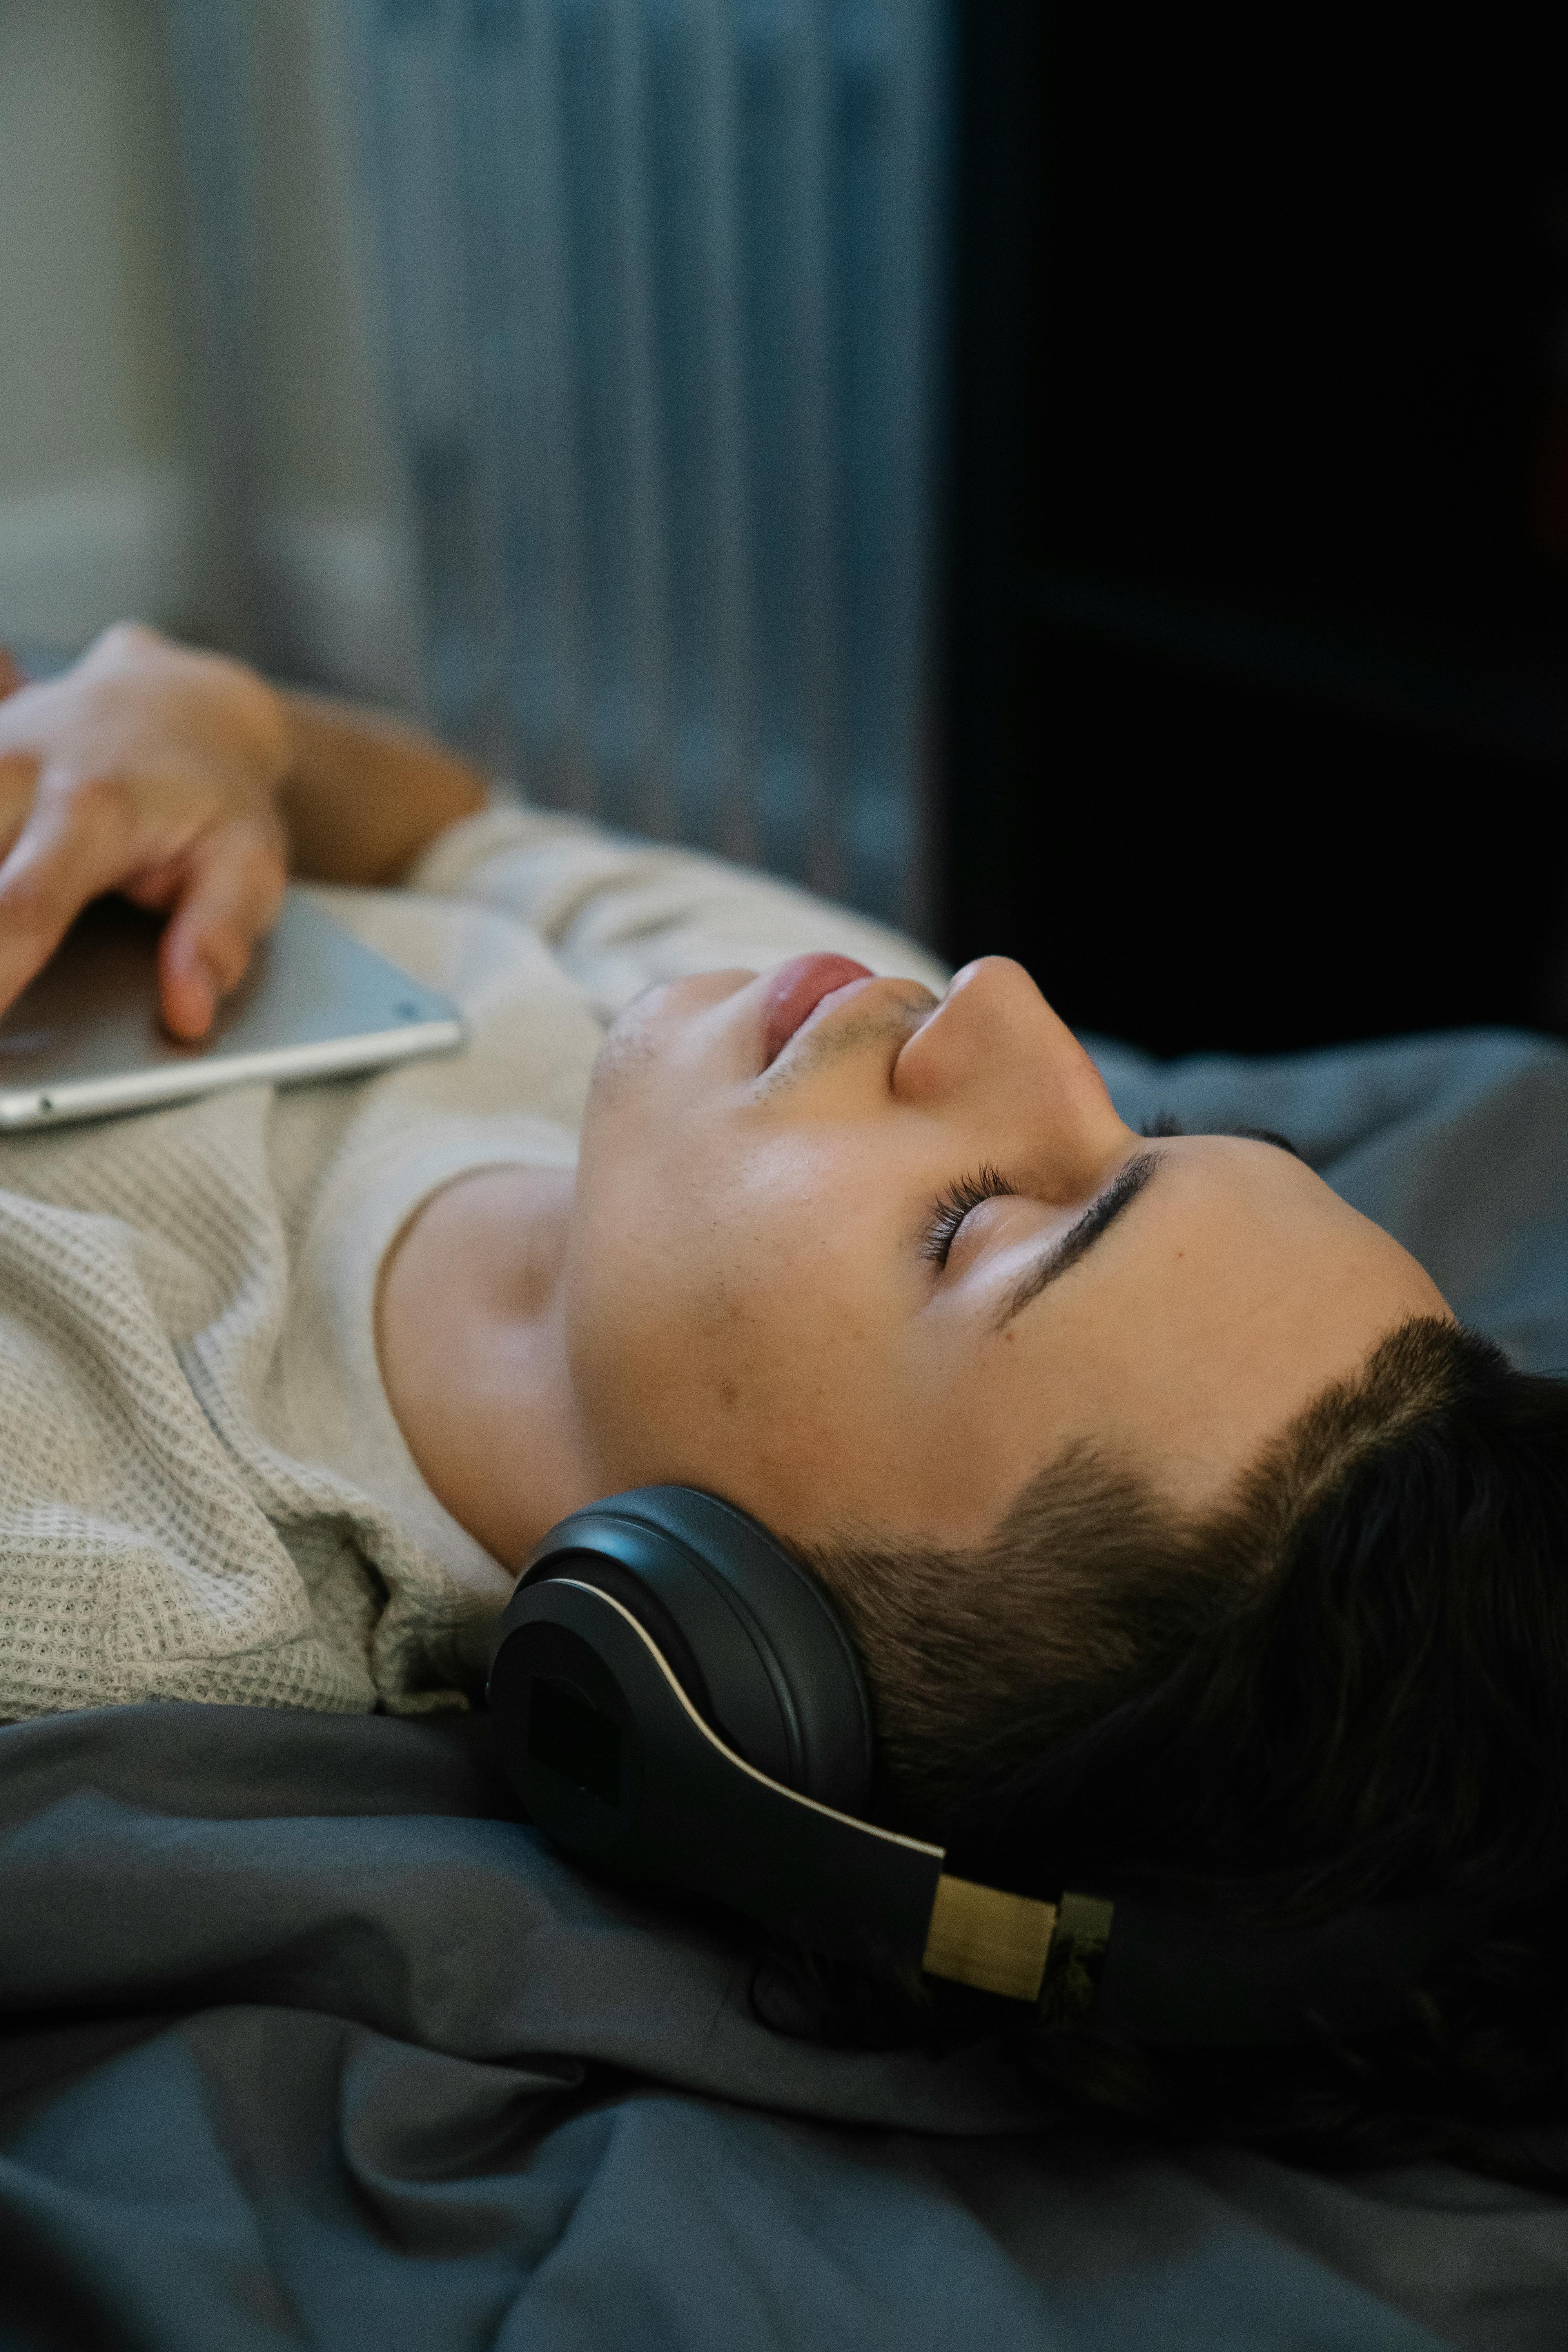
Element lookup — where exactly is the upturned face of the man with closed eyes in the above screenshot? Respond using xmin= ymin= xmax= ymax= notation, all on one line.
xmin=566 ymin=957 xmax=1448 ymax=1548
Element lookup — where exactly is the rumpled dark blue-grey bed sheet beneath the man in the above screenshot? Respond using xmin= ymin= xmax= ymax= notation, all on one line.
xmin=0 ymin=1037 xmax=1568 ymax=2352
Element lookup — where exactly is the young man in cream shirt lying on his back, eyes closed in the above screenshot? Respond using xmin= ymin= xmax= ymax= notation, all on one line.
xmin=0 ymin=628 xmax=1568 ymax=2161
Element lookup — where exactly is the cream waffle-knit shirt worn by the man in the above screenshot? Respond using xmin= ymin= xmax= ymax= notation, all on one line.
xmin=0 ymin=807 xmax=943 ymax=1719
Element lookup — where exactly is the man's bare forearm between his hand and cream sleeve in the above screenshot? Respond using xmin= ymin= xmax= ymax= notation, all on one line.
xmin=278 ymin=691 xmax=484 ymax=882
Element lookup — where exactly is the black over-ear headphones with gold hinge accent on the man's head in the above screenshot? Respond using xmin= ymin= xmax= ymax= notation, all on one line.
xmin=489 ymin=1486 xmax=1443 ymax=2046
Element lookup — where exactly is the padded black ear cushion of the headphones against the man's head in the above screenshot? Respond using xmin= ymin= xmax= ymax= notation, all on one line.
xmin=515 ymin=1486 xmax=872 ymax=1813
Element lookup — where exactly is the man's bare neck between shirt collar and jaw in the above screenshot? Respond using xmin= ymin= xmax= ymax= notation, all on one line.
xmin=376 ymin=1167 xmax=597 ymax=1569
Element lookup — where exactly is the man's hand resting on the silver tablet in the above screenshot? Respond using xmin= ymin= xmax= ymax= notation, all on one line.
xmin=0 ymin=623 xmax=292 ymax=1037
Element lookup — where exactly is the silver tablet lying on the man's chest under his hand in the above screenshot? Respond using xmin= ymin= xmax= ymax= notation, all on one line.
xmin=0 ymin=889 xmax=463 ymax=1129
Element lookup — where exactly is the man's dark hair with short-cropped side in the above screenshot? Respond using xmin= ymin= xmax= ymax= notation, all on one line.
xmin=809 ymin=1317 xmax=1568 ymax=2180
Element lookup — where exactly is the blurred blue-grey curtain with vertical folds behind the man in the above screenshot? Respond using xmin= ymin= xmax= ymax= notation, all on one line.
xmin=167 ymin=0 xmax=950 ymax=929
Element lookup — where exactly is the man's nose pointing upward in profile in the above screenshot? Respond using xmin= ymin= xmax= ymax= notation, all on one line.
xmin=893 ymin=955 xmax=1129 ymax=1195
